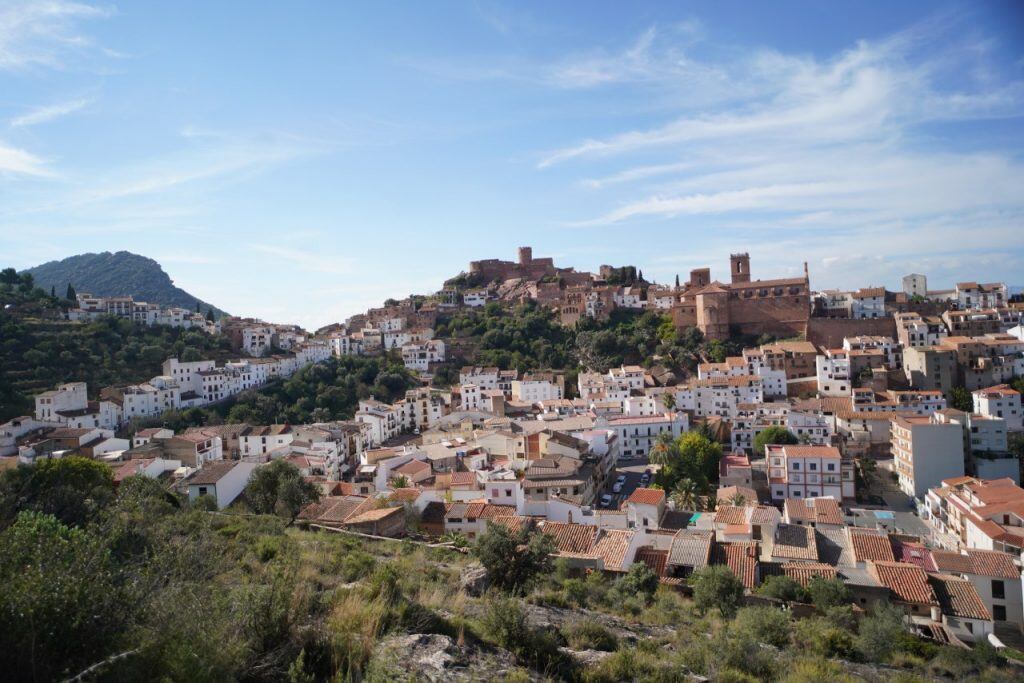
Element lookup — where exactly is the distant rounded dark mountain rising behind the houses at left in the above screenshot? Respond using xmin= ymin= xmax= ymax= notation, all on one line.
xmin=24 ymin=251 xmax=225 ymax=316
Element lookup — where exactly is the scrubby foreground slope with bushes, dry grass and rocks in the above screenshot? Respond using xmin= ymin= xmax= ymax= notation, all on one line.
xmin=0 ymin=457 xmax=1021 ymax=683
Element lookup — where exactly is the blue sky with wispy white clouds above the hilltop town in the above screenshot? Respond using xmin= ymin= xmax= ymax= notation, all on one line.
xmin=0 ymin=0 xmax=1024 ymax=329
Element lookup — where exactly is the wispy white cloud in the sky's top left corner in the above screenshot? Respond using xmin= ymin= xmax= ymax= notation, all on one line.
xmin=0 ymin=0 xmax=116 ymax=71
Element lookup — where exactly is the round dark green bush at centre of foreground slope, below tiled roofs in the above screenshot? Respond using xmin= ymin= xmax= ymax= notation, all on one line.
xmin=474 ymin=524 xmax=555 ymax=593
